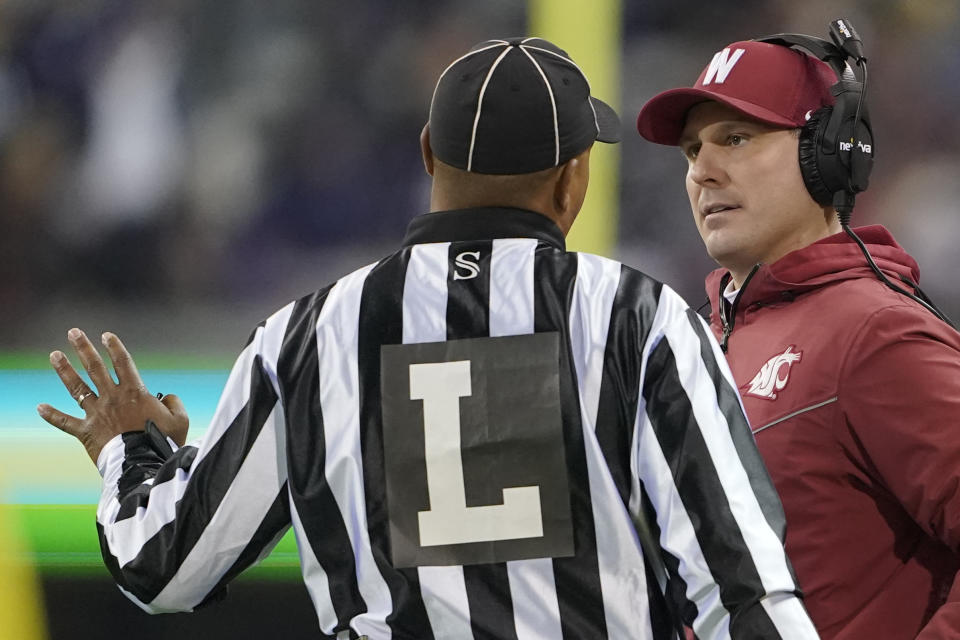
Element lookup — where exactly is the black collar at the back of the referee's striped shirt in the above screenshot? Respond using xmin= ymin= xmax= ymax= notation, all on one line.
xmin=403 ymin=207 xmax=566 ymax=250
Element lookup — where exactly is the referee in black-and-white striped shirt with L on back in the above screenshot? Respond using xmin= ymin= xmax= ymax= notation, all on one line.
xmin=39 ymin=38 xmax=817 ymax=640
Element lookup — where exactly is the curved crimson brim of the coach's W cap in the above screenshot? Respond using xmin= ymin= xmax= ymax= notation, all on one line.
xmin=637 ymin=87 xmax=803 ymax=146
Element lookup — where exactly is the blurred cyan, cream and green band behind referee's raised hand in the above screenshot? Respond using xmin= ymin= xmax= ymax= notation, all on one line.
xmin=0 ymin=353 xmax=299 ymax=579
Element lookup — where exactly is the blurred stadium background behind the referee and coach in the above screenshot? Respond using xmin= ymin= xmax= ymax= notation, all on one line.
xmin=0 ymin=0 xmax=960 ymax=640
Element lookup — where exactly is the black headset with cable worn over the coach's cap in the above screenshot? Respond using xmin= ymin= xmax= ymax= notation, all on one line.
xmin=754 ymin=18 xmax=957 ymax=329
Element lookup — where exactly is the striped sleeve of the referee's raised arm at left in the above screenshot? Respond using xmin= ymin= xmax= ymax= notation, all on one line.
xmin=97 ymin=312 xmax=290 ymax=613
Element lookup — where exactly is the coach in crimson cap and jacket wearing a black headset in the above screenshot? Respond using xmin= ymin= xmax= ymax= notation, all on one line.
xmin=638 ymin=19 xmax=960 ymax=640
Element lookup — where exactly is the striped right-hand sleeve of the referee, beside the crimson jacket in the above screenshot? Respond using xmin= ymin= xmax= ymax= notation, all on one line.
xmin=634 ymin=287 xmax=818 ymax=640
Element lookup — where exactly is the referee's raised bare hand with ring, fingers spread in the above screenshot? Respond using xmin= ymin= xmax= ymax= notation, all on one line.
xmin=37 ymin=329 xmax=189 ymax=464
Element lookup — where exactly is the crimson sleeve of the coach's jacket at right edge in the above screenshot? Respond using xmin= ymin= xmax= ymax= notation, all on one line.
xmin=840 ymin=303 xmax=960 ymax=640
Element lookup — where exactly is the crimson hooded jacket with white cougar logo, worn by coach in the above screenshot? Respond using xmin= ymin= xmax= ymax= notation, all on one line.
xmin=707 ymin=226 xmax=960 ymax=640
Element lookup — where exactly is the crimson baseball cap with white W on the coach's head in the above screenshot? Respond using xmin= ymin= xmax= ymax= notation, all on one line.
xmin=637 ymin=40 xmax=837 ymax=145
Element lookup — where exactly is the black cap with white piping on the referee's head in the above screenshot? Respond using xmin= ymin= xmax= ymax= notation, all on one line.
xmin=429 ymin=38 xmax=620 ymax=174
